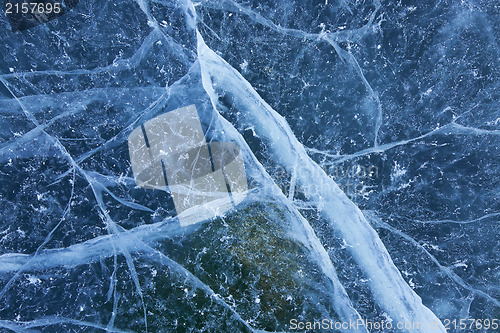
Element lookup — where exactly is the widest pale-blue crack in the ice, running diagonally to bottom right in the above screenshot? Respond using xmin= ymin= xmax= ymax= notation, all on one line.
xmin=194 ymin=27 xmax=446 ymax=333
